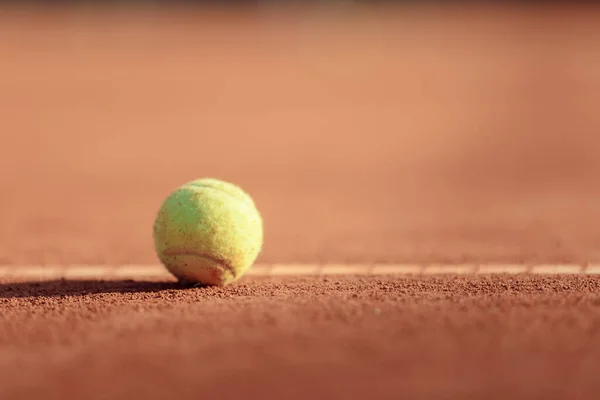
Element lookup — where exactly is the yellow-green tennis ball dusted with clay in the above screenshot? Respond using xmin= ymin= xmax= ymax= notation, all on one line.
xmin=153 ymin=178 xmax=263 ymax=286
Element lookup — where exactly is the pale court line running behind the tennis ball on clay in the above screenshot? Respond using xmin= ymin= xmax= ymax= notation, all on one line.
xmin=0 ymin=264 xmax=600 ymax=280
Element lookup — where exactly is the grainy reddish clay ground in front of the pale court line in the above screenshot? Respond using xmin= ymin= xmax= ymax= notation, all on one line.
xmin=0 ymin=276 xmax=600 ymax=400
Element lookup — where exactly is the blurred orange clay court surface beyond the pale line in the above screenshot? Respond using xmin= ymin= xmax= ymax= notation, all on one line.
xmin=0 ymin=1 xmax=600 ymax=264
